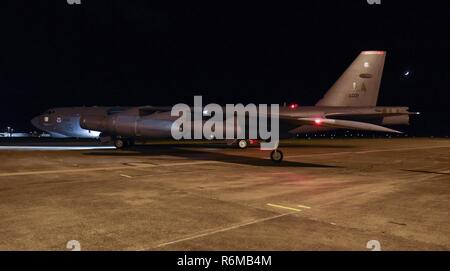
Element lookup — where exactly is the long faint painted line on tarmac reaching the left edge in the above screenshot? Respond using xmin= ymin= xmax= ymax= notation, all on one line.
xmin=0 ymin=161 xmax=223 ymax=177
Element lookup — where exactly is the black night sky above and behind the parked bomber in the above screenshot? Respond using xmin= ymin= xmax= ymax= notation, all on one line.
xmin=0 ymin=0 xmax=450 ymax=135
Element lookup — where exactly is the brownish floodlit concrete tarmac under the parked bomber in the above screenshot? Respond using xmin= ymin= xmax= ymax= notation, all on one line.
xmin=0 ymin=138 xmax=450 ymax=250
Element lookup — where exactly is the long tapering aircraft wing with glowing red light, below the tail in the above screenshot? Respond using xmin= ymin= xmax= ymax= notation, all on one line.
xmin=280 ymin=117 xmax=402 ymax=133
